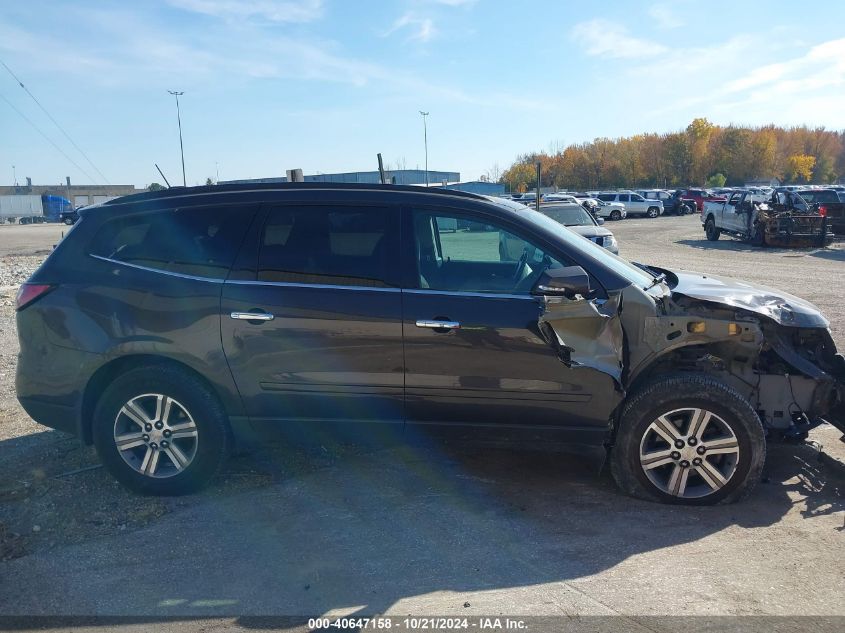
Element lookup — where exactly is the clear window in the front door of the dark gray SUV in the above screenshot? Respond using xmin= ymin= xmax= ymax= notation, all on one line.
xmin=414 ymin=211 xmax=563 ymax=295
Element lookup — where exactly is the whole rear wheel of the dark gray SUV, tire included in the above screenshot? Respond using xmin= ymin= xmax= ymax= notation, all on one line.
xmin=93 ymin=365 xmax=231 ymax=495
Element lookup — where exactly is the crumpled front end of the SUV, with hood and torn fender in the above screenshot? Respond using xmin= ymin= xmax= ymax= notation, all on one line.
xmin=538 ymin=271 xmax=845 ymax=440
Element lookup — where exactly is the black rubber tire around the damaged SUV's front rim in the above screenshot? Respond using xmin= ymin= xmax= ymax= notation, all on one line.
xmin=610 ymin=373 xmax=766 ymax=505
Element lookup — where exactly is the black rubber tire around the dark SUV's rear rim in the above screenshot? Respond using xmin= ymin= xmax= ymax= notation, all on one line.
xmin=92 ymin=365 xmax=232 ymax=495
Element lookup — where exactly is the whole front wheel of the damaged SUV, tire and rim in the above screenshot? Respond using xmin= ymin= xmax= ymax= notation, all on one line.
xmin=611 ymin=374 xmax=766 ymax=505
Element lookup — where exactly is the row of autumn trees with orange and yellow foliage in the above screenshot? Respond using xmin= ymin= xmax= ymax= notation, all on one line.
xmin=498 ymin=118 xmax=845 ymax=191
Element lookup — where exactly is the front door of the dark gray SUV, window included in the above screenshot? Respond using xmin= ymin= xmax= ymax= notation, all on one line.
xmin=403 ymin=209 xmax=618 ymax=441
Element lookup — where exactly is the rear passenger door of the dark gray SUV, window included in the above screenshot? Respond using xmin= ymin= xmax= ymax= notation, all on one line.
xmin=222 ymin=204 xmax=403 ymax=424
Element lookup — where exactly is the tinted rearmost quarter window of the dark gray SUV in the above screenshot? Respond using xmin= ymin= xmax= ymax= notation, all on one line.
xmin=90 ymin=206 xmax=254 ymax=279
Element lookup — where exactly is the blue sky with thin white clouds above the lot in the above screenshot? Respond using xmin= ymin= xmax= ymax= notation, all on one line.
xmin=0 ymin=0 xmax=845 ymax=186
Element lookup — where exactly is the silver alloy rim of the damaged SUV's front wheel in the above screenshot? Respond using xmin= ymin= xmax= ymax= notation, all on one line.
xmin=640 ymin=407 xmax=740 ymax=499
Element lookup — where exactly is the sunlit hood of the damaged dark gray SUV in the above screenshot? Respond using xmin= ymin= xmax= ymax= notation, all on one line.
xmin=665 ymin=270 xmax=830 ymax=328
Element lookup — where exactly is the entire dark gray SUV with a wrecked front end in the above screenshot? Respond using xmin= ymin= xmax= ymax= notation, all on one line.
xmin=17 ymin=183 xmax=845 ymax=504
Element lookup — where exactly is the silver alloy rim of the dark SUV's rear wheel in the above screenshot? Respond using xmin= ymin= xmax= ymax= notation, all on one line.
xmin=114 ymin=393 xmax=199 ymax=479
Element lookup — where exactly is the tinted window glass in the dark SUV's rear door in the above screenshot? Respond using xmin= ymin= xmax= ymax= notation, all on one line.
xmin=258 ymin=206 xmax=399 ymax=287
